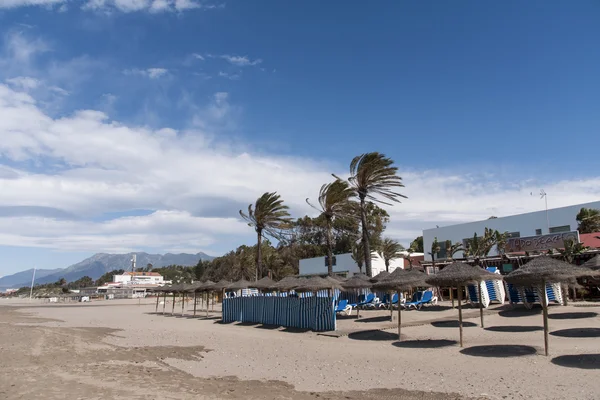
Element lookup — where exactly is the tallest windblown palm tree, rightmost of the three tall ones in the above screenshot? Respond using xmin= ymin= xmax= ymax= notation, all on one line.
xmin=336 ymin=152 xmax=406 ymax=276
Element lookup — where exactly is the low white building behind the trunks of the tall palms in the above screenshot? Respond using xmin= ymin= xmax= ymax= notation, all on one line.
xmin=300 ymin=253 xmax=423 ymax=277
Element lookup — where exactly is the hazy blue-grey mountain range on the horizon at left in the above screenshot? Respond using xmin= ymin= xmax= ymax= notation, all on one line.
xmin=0 ymin=252 xmax=214 ymax=289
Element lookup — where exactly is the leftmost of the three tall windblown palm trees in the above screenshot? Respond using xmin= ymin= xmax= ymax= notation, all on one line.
xmin=240 ymin=192 xmax=292 ymax=280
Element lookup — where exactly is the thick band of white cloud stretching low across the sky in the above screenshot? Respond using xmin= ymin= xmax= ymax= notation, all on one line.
xmin=0 ymin=84 xmax=600 ymax=253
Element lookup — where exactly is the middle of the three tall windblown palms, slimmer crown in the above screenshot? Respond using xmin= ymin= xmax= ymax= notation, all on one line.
xmin=306 ymin=179 xmax=355 ymax=276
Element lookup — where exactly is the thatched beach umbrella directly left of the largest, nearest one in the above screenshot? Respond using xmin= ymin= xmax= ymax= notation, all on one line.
xmin=425 ymin=262 xmax=502 ymax=347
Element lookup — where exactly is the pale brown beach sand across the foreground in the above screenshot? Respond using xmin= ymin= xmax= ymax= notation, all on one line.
xmin=0 ymin=299 xmax=600 ymax=400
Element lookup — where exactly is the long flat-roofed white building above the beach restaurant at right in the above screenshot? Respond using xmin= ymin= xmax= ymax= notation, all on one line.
xmin=423 ymin=201 xmax=600 ymax=260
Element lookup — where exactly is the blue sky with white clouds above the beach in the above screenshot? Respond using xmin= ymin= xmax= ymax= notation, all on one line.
xmin=0 ymin=0 xmax=600 ymax=275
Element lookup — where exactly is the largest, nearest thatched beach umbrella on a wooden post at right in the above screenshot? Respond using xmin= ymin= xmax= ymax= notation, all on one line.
xmin=504 ymin=256 xmax=600 ymax=356
